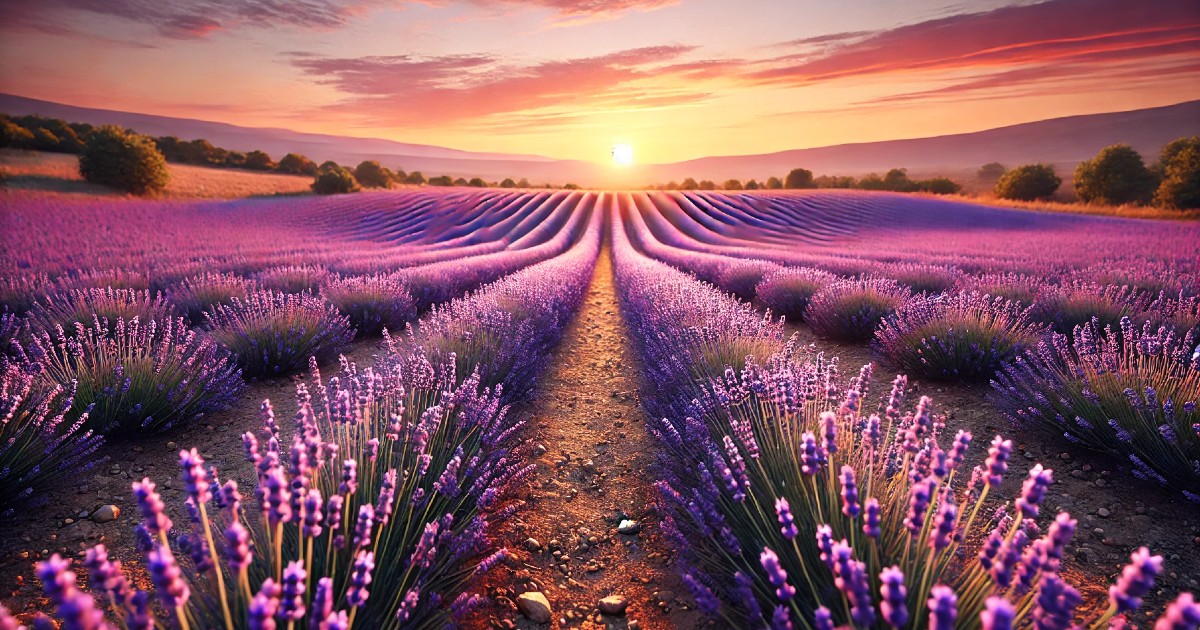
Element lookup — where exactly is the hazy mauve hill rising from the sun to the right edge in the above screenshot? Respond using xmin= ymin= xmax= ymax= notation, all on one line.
xmin=648 ymin=101 xmax=1200 ymax=181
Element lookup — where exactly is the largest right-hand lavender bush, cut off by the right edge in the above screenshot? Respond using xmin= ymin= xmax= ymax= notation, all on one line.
xmin=992 ymin=318 xmax=1200 ymax=503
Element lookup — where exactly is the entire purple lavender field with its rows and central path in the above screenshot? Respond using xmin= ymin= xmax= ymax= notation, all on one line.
xmin=0 ymin=192 xmax=1200 ymax=630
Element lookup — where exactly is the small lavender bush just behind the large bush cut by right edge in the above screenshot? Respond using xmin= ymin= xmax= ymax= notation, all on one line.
xmin=1032 ymin=282 xmax=1146 ymax=335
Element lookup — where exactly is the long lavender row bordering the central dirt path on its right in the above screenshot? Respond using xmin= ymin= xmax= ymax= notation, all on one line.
xmin=614 ymin=212 xmax=1200 ymax=629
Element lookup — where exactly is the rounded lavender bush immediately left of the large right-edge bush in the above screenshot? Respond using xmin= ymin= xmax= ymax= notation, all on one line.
xmin=872 ymin=292 xmax=1044 ymax=379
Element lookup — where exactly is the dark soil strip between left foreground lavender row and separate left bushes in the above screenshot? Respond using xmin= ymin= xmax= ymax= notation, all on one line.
xmin=0 ymin=338 xmax=383 ymax=623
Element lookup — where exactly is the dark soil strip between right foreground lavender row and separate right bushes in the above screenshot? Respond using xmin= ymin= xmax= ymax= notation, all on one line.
xmin=787 ymin=324 xmax=1200 ymax=622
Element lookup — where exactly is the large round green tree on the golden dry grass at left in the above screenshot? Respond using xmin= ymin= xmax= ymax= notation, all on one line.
xmin=79 ymin=125 xmax=170 ymax=194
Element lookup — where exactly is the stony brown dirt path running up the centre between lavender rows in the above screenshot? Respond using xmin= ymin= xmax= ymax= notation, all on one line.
xmin=475 ymin=248 xmax=708 ymax=629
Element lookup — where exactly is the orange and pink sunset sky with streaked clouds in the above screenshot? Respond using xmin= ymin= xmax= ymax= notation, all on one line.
xmin=0 ymin=0 xmax=1200 ymax=163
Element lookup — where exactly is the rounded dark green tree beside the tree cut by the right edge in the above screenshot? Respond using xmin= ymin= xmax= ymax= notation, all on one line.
xmin=1075 ymin=144 xmax=1157 ymax=205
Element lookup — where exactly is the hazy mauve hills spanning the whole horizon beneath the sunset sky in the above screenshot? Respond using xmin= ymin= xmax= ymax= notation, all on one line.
xmin=0 ymin=94 xmax=1200 ymax=186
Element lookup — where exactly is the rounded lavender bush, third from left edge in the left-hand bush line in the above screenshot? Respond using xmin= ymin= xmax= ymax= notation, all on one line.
xmin=205 ymin=290 xmax=354 ymax=376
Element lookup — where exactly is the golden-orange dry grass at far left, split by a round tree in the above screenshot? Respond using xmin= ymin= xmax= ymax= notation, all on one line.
xmin=0 ymin=149 xmax=312 ymax=199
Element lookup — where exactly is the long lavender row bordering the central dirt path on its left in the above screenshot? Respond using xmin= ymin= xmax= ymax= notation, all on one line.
xmin=25 ymin=196 xmax=601 ymax=628
